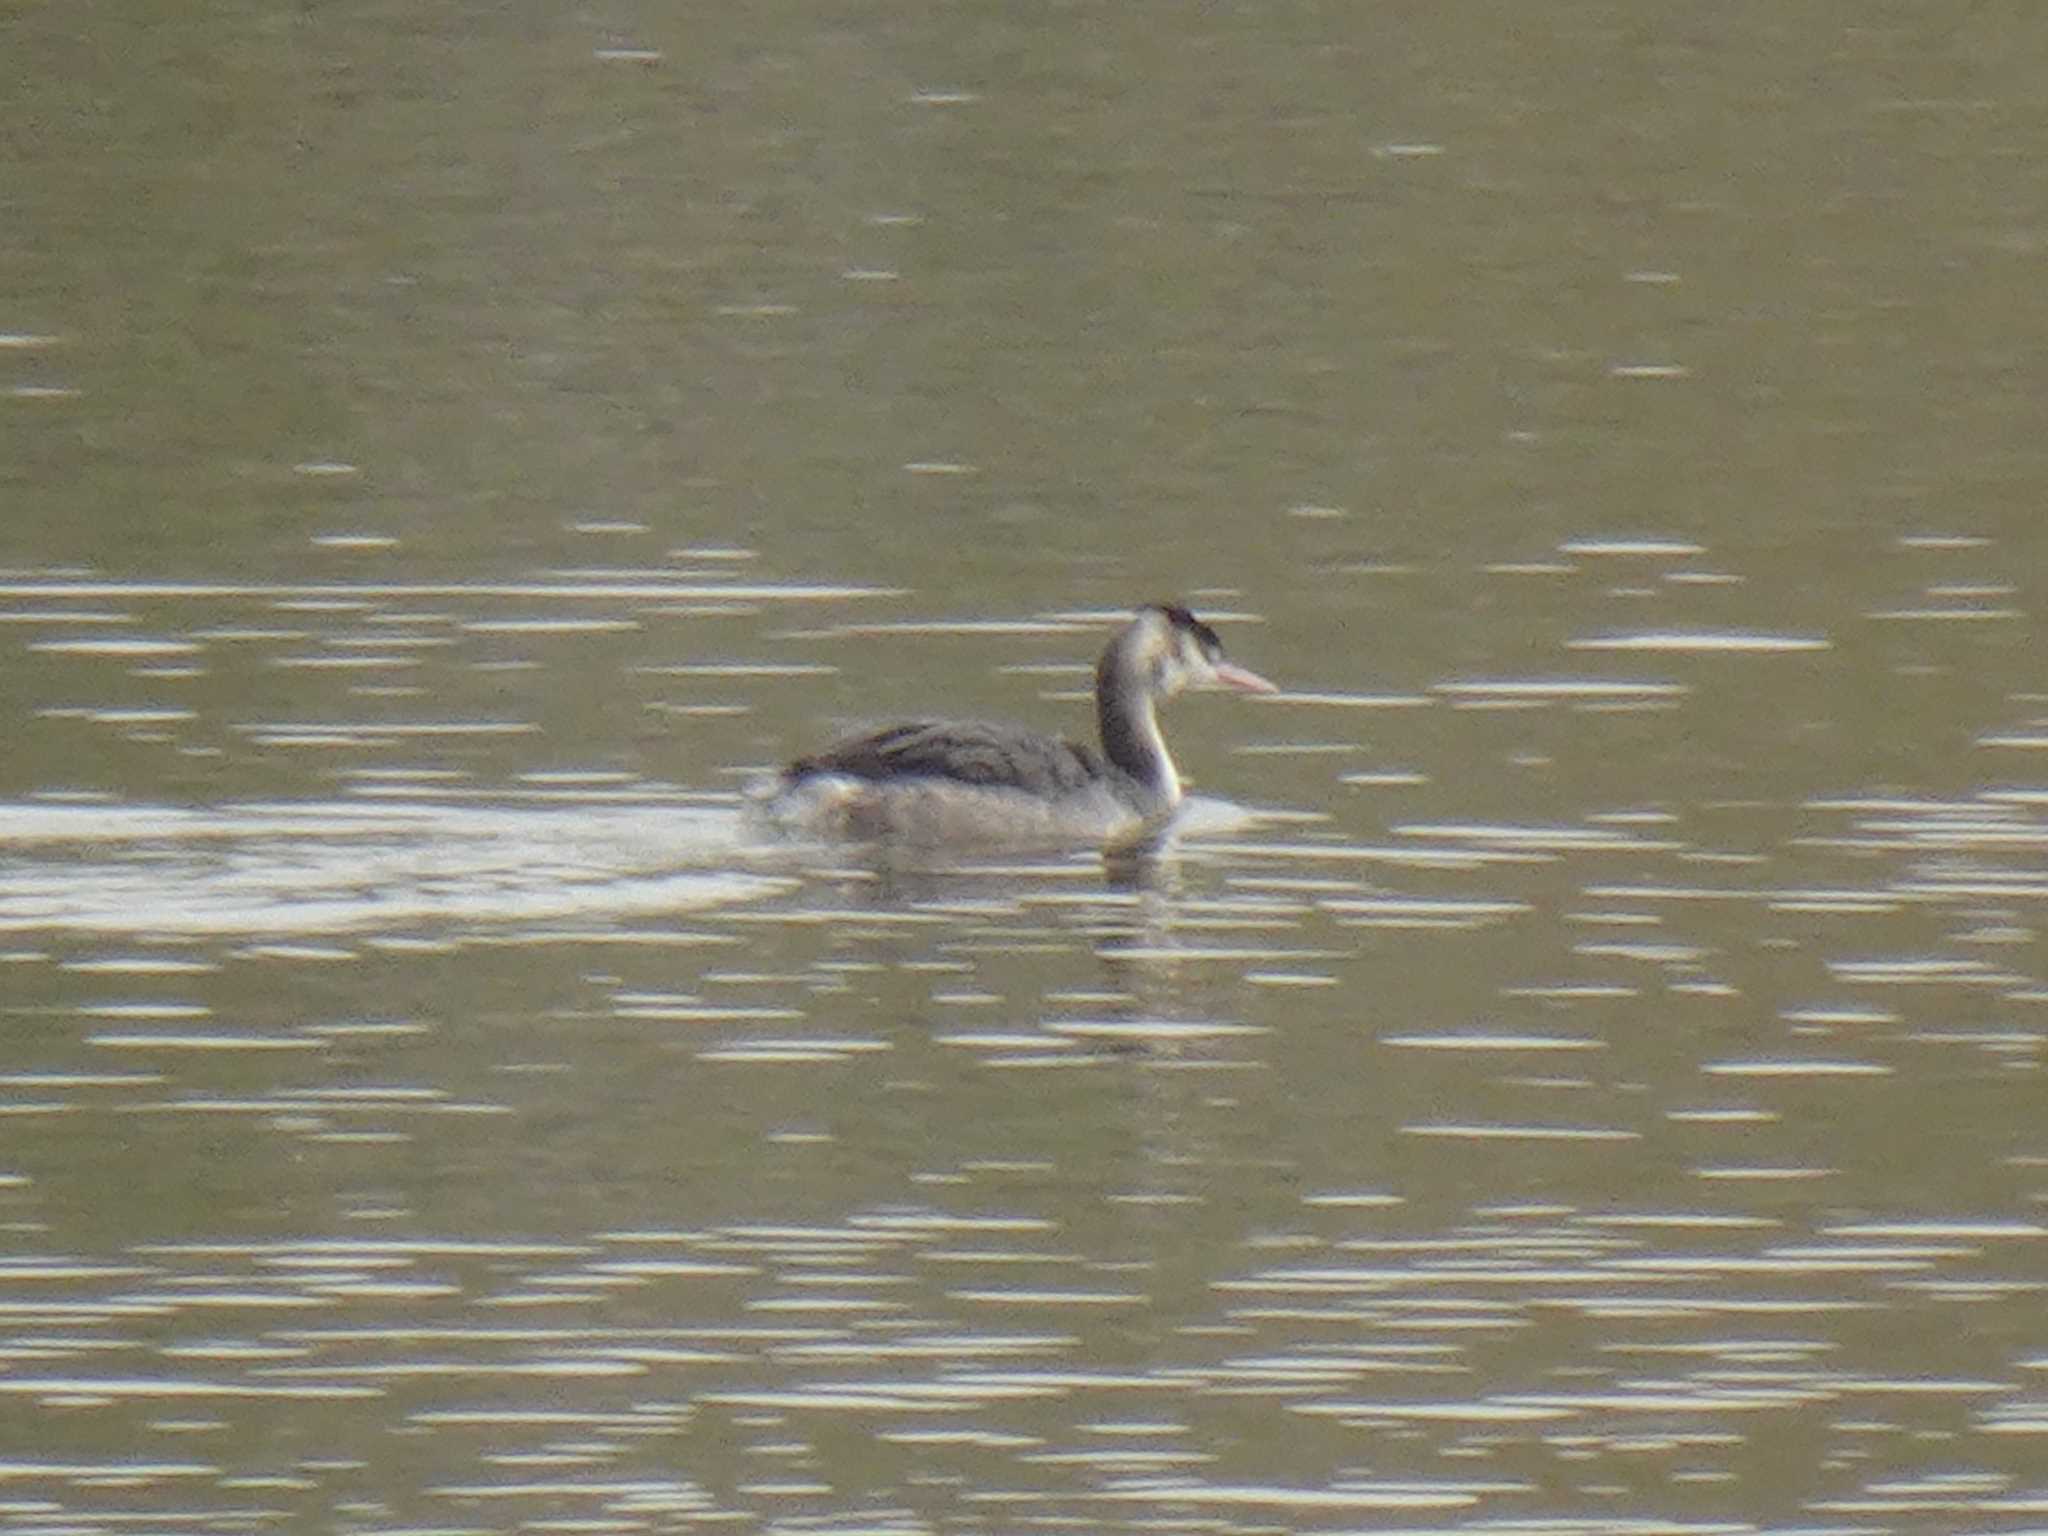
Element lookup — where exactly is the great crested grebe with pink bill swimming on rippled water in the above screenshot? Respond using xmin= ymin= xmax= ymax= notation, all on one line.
xmin=752 ymin=604 xmax=1276 ymax=844
